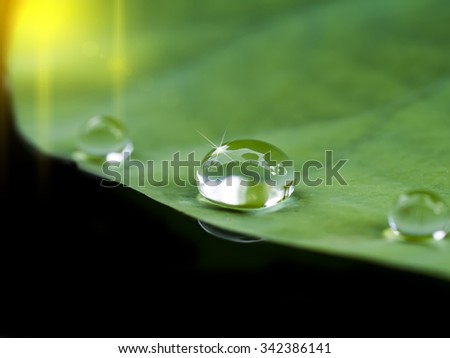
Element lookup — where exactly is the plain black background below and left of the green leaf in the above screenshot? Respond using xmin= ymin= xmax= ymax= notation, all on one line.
xmin=0 ymin=0 xmax=450 ymax=337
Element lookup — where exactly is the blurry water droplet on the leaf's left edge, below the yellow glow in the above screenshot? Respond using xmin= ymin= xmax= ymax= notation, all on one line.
xmin=77 ymin=116 xmax=133 ymax=161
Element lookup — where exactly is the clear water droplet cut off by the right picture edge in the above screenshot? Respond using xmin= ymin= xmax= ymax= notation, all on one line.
xmin=388 ymin=190 xmax=449 ymax=240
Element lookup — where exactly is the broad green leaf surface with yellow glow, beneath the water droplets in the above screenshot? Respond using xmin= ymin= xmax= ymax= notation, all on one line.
xmin=10 ymin=0 xmax=450 ymax=278
